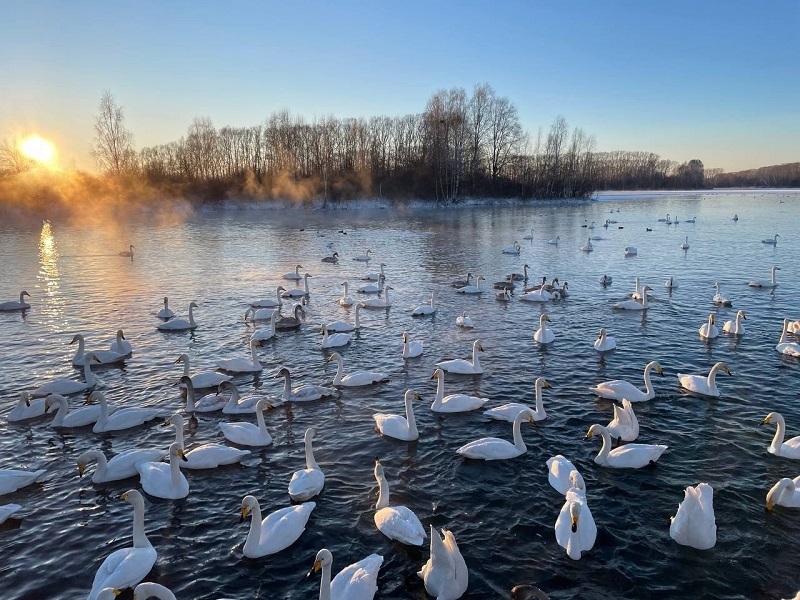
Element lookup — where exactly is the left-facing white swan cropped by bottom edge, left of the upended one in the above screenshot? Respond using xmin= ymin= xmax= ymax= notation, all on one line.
xmin=309 ymin=548 xmax=383 ymax=600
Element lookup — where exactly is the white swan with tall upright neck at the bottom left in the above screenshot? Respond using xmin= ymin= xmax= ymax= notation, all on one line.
xmin=87 ymin=490 xmax=157 ymax=600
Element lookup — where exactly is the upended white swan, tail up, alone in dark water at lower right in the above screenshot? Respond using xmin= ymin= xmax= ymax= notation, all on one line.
xmin=669 ymin=483 xmax=717 ymax=550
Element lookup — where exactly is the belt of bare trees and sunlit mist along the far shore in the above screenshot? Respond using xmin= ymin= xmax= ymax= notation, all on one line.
xmin=0 ymin=83 xmax=800 ymax=225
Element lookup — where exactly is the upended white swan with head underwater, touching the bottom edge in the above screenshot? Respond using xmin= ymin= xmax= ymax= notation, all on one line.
xmin=417 ymin=525 xmax=469 ymax=600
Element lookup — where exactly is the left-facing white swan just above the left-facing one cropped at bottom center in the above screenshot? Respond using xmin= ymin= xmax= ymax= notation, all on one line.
xmin=242 ymin=494 xmax=317 ymax=558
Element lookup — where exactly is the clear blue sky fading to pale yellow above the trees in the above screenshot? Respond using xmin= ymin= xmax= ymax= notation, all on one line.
xmin=0 ymin=0 xmax=800 ymax=171
